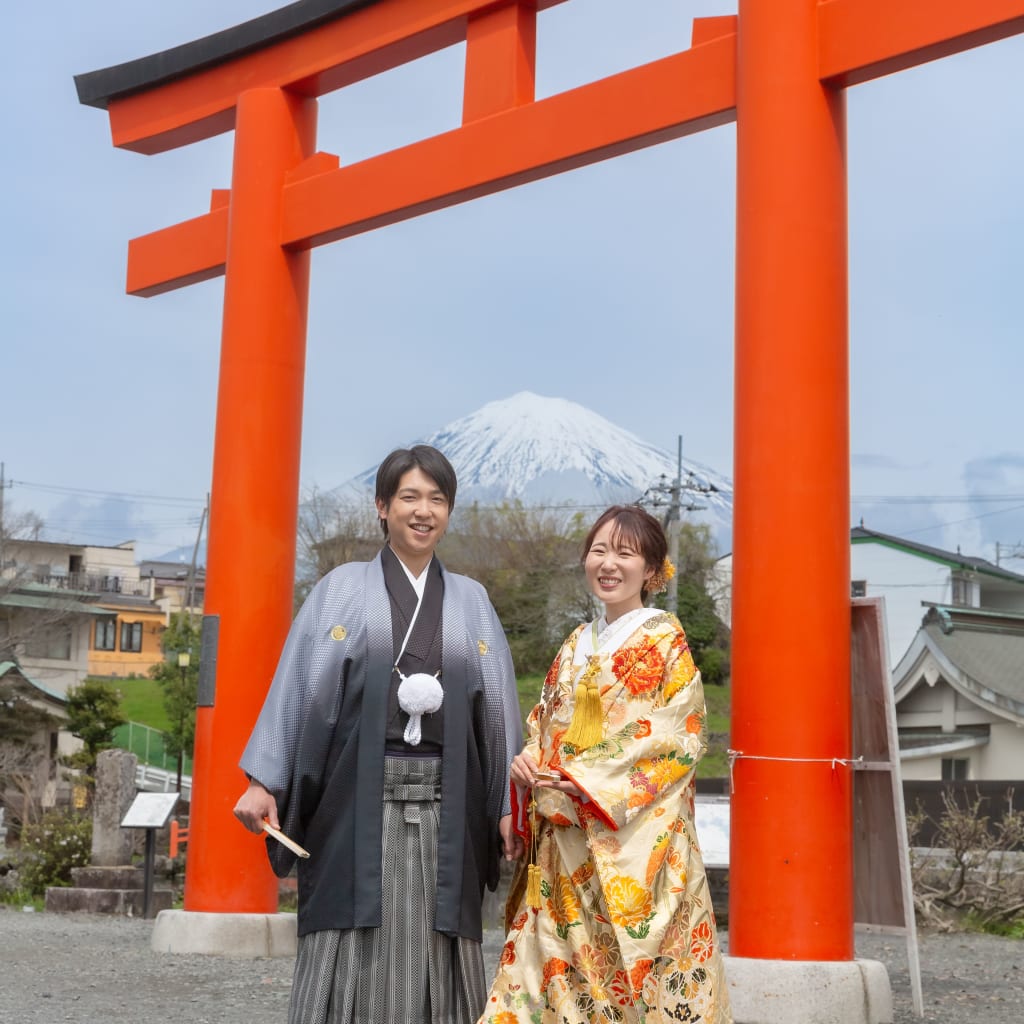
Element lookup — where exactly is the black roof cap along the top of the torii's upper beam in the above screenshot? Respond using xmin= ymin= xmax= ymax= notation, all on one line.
xmin=75 ymin=0 xmax=380 ymax=110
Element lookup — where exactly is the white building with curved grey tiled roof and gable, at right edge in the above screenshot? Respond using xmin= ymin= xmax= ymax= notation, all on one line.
xmin=893 ymin=604 xmax=1024 ymax=779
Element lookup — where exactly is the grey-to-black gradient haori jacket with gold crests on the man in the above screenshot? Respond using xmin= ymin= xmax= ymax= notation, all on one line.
xmin=241 ymin=555 xmax=522 ymax=941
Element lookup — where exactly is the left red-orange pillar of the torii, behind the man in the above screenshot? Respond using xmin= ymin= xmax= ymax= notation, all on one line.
xmin=185 ymin=88 xmax=316 ymax=913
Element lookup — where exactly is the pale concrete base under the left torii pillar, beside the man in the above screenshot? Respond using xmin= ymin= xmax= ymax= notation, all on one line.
xmin=150 ymin=910 xmax=298 ymax=957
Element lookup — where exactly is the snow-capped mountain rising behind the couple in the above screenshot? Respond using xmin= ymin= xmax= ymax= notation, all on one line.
xmin=337 ymin=391 xmax=732 ymax=534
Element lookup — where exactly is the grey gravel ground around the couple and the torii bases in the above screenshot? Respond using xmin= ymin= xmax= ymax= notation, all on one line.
xmin=0 ymin=908 xmax=1024 ymax=1024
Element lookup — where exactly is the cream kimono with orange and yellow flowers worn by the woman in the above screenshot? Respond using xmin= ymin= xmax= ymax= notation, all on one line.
xmin=480 ymin=608 xmax=732 ymax=1024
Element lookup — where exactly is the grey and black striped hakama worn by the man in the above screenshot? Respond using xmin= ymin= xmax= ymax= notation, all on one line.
xmin=288 ymin=757 xmax=487 ymax=1024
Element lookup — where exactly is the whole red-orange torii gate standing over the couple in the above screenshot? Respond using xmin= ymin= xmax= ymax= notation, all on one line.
xmin=76 ymin=0 xmax=1024 ymax=961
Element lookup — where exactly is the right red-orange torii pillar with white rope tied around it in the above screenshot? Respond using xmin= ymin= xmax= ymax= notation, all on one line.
xmin=729 ymin=0 xmax=853 ymax=961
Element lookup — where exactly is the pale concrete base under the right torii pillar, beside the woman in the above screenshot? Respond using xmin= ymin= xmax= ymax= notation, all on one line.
xmin=725 ymin=956 xmax=893 ymax=1024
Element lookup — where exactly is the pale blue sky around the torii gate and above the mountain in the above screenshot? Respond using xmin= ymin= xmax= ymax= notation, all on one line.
xmin=0 ymin=0 xmax=1024 ymax=572
